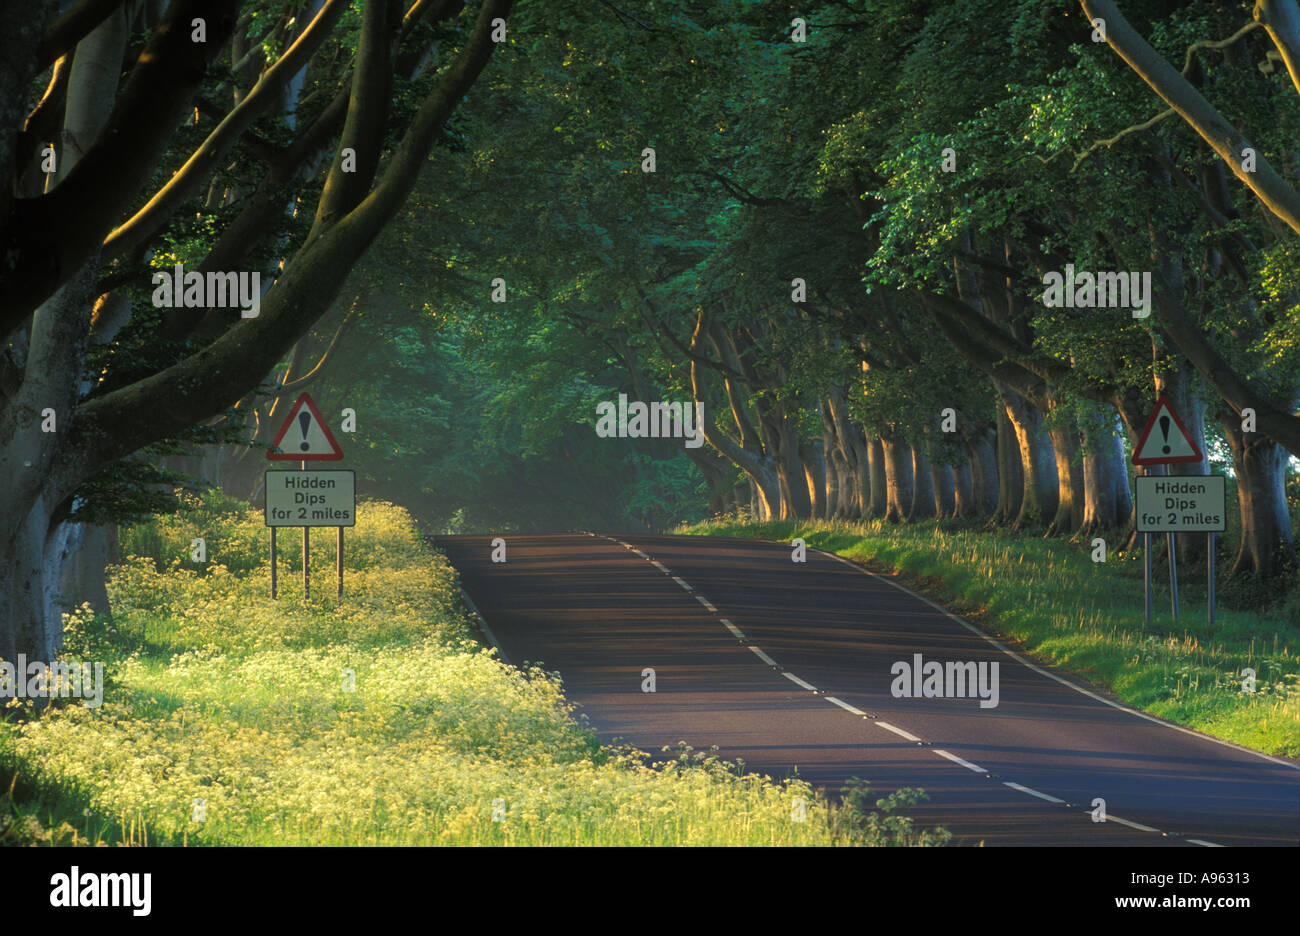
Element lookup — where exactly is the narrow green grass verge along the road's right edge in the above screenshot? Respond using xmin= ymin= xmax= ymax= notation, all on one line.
xmin=679 ymin=519 xmax=1300 ymax=757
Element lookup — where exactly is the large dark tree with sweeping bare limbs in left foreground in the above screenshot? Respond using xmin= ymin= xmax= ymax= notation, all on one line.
xmin=0 ymin=0 xmax=512 ymax=659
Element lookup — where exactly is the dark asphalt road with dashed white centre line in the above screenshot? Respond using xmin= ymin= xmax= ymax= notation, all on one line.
xmin=437 ymin=534 xmax=1300 ymax=848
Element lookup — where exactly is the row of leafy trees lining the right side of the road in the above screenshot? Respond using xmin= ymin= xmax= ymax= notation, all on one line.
xmin=397 ymin=0 xmax=1300 ymax=577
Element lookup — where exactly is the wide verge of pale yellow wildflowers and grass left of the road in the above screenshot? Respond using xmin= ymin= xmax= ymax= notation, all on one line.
xmin=0 ymin=495 xmax=945 ymax=845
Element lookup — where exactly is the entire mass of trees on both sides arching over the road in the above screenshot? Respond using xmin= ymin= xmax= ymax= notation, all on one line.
xmin=0 ymin=0 xmax=1300 ymax=659
